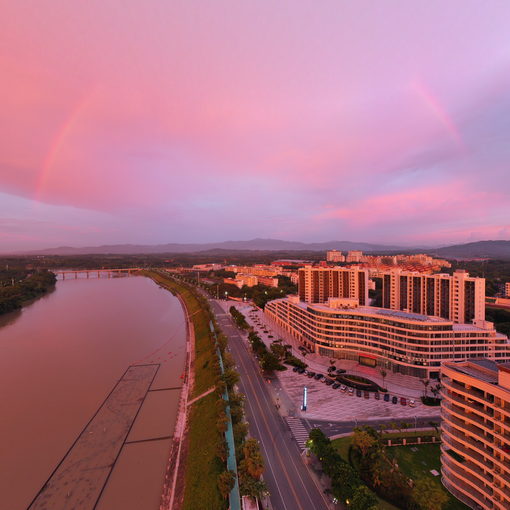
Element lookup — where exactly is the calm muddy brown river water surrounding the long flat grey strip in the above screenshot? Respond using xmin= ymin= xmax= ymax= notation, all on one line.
xmin=0 ymin=276 xmax=186 ymax=510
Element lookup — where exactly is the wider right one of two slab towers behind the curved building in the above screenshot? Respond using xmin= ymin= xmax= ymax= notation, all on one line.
xmin=379 ymin=269 xmax=485 ymax=324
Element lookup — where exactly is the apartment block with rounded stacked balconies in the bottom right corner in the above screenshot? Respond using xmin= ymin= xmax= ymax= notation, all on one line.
xmin=441 ymin=359 xmax=510 ymax=510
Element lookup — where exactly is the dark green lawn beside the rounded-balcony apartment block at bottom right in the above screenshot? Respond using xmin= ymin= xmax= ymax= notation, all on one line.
xmin=386 ymin=444 xmax=468 ymax=510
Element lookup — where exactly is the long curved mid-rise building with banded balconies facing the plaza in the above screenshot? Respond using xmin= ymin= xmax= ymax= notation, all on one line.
xmin=265 ymin=297 xmax=510 ymax=378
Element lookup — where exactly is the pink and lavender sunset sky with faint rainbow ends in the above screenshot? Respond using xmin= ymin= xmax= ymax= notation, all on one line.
xmin=0 ymin=0 xmax=510 ymax=252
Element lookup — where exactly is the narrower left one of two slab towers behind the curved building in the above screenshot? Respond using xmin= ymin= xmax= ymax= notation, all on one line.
xmin=298 ymin=266 xmax=368 ymax=305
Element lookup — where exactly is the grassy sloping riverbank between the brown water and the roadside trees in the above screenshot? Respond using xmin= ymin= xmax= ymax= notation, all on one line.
xmin=142 ymin=271 xmax=226 ymax=510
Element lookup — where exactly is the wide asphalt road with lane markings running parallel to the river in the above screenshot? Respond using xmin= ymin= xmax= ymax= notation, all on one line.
xmin=211 ymin=301 xmax=329 ymax=510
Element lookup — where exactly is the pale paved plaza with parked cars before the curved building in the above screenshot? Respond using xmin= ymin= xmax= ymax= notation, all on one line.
xmin=220 ymin=301 xmax=439 ymax=423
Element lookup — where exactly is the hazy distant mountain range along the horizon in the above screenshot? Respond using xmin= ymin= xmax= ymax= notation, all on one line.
xmin=10 ymin=239 xmax=510 ymax=258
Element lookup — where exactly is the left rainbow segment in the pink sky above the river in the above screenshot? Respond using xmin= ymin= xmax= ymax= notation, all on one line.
xmin=34 ymin=89 xmax=97 ymax=201
